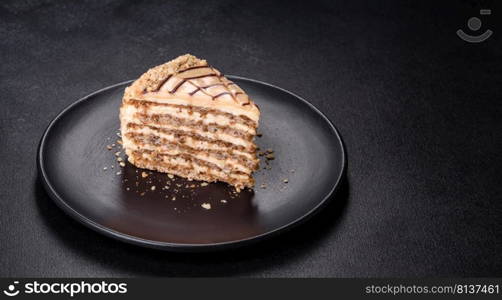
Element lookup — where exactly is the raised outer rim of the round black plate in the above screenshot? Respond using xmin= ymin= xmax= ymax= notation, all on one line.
xmin=37 ymin=75 xmax=347 ymax=252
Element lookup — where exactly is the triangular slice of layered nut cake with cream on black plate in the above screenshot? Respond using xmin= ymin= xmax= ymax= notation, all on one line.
xmin=120 ymin=54 xmax=260 ymax=189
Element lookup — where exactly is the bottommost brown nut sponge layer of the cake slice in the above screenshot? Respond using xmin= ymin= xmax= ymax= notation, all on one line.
xmin=126 ymin=149 xmax=254 ymax=188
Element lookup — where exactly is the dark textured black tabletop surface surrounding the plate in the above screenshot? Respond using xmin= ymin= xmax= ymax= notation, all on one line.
xmin=0 ymin=1 xmax=502 ymax=277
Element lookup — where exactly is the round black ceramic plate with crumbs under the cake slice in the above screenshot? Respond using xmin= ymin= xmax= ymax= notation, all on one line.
xmin=37 ymin=76 xmax=345 ymax=251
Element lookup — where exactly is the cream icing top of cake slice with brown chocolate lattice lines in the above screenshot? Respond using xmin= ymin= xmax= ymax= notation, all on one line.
xmin=124 ymin=54 xmax=259 ymax=117
